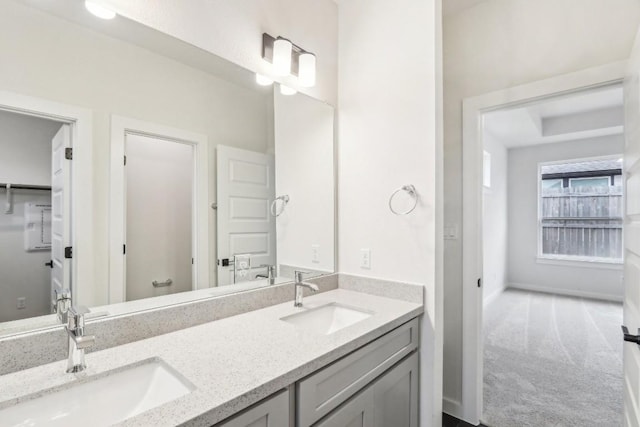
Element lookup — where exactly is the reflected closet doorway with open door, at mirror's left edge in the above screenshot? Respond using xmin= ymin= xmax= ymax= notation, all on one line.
xmin=0 ymin=110 xmax=71 ymax=322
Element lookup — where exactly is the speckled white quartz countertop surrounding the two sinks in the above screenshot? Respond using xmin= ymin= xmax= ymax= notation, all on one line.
xmin=0 ymin=289 xmax=423 ymax=427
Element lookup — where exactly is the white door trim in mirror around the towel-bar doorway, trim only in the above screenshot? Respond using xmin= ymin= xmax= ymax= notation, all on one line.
xmin=108 ymin=115 xmax=210 ymax=304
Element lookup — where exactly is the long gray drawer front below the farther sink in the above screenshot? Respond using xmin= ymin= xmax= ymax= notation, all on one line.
xmin=296 ymin=318 xmax=420 ymax=427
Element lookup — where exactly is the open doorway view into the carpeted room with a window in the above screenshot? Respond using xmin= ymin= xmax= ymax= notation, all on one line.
xmin=480 ymin=84 xmax=624 ymax=427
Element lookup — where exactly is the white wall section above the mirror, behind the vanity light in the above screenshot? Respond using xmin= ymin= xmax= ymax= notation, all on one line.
xmin=102 ymin=0 xmax=338 ymax=105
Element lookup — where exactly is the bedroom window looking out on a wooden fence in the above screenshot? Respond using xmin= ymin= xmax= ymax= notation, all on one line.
xmin=538 ymin=158 xmax=623 ymax=262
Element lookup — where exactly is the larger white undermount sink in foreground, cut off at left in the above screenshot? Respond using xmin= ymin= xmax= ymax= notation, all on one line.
xmin=0 ymin=359 xmax=195 ymax=427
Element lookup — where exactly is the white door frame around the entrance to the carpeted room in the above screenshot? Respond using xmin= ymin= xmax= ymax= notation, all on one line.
xmin=458 ymin=61 xmax=627 ymax=425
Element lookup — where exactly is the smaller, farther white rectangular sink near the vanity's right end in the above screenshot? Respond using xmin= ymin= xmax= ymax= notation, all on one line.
xmin=280 ymin=303 xmax=373 ymax=335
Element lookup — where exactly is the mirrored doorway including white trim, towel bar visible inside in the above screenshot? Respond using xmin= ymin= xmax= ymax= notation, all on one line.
xmin=109 ymin=116 xmax=209 ymax=304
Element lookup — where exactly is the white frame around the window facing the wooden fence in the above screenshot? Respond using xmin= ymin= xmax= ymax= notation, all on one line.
xmin=536 ymin=154 xmax=626 ymax=268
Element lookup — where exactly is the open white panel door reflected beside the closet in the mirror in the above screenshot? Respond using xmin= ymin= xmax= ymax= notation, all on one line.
xmin=51 ymin=125 xmax=73 ymax=308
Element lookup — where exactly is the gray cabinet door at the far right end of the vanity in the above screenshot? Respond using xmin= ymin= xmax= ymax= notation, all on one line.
xmin=372 ymin=353 xmax=419 ymax=427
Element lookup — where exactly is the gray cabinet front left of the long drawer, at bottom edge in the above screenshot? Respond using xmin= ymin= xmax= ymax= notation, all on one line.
xmin=215 ymin=390 xmax=289 ymax=427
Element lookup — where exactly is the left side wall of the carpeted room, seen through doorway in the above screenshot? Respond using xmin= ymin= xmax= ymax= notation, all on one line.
xmin=482 ymin=132 xmax=509 ymax=302
